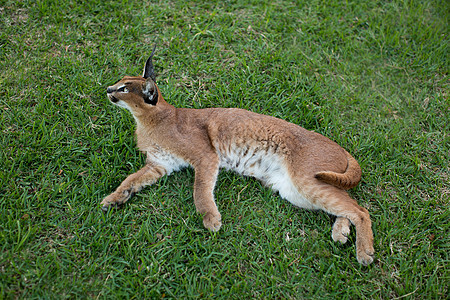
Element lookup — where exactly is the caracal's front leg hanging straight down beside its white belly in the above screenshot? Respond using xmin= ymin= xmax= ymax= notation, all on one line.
xmin=194 ymin=156 xmax=222 ymax=232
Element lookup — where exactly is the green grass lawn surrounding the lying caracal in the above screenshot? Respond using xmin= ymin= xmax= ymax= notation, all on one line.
xmin=0 ymin=0 xmax=450 ymax=299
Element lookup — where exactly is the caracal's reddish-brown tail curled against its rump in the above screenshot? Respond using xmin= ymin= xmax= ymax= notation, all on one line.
xmin=314 ymin=150 xmax=361 ymax=190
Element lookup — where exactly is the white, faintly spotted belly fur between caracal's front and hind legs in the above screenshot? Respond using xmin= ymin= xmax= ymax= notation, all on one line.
xmin=219 ymin=148 xmax=316 ymax=209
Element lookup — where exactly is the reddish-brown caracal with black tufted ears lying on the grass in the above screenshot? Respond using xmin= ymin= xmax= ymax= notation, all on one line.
xmin=102 ymin=49 xmax=374 ymax=265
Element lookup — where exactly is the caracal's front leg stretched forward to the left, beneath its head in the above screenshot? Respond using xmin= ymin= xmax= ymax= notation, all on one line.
xmin=102 ymin=164 xmax=166 ymax=211
